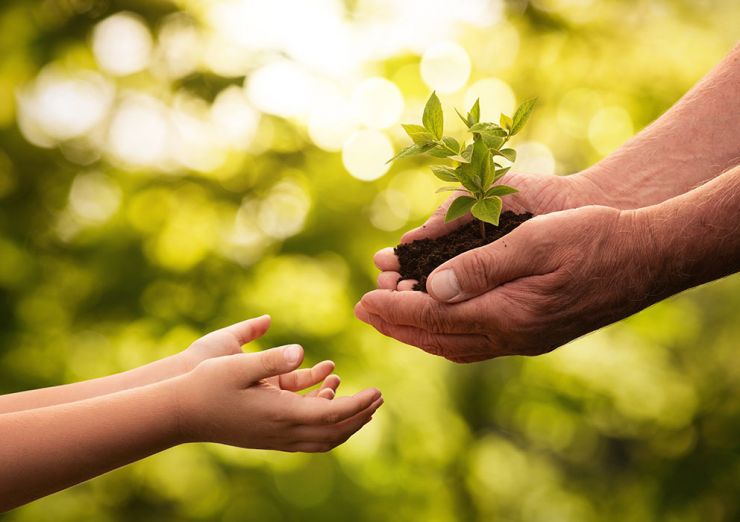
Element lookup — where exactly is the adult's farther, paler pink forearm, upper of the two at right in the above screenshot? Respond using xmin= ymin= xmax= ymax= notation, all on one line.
xmin=578 ymin=44 xmax=740 ymax=209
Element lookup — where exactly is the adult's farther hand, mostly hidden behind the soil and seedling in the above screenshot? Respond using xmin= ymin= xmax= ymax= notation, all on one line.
xmin=374 ymin=172 xmax=603 ymax=290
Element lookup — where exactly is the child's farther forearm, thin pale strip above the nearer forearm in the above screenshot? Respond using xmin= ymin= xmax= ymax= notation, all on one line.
xmin=0 ymin=354 xmax=188 ymax=414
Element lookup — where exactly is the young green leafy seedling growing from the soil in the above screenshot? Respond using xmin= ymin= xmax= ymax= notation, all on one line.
xmin=388 ymin=92 xmax=537 ymax=238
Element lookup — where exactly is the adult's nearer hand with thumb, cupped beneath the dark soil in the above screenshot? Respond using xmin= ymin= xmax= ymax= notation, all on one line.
xmin=355 ymin=206 xmax=660 ymax=362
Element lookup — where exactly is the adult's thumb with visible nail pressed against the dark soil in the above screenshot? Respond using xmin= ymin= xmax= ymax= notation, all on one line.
xmin=426 ymin=221 xmax=545 ymax=303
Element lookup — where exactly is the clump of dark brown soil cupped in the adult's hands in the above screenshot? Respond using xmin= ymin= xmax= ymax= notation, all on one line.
xmin=394 ymin=212 xmax=532 ymax=292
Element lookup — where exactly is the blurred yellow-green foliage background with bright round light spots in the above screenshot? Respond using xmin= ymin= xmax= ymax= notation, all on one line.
xmin=0 ymin=0 xmax=740 ymax=522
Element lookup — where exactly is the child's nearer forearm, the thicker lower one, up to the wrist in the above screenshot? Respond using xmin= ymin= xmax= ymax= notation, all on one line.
xmin=0 ymin=379 xmax=178 ymax=511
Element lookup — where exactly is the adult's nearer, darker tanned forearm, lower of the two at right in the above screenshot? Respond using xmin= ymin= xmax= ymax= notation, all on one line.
xmin=633 ymin=165 xmax=740 ymax=297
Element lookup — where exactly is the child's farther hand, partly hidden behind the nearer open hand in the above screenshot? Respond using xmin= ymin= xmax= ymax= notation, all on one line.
xmin=178 ymin=315 xmax=340 ymax=399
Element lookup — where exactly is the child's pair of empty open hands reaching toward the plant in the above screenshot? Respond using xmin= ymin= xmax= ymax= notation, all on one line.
xmin=173 ymin=316 xmax=383 ymax=452
